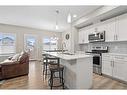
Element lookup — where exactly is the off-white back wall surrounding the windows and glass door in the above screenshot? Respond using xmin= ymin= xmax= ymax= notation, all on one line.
xmin=0 ymin=24 xmax=62 ymax=59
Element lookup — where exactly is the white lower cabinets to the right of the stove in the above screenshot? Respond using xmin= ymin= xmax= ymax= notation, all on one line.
xmin=102 ymin=54 xmax=127 ymax=81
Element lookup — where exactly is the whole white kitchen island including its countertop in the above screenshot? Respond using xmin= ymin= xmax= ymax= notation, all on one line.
xmin=43 ymin=52 xmax=93 ymax=89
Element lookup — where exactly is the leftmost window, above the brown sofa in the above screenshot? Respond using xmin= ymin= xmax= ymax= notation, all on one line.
xmin=0 ymin=33 xmax=16 ymax=54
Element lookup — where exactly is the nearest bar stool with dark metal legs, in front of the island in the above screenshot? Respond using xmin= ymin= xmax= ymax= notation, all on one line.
xmin=49 ymin=64 xmax=64 ymax=89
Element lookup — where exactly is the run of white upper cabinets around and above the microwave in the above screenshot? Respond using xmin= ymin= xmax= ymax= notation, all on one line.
xmin=79 ymin=14 xmax=127 ymax=44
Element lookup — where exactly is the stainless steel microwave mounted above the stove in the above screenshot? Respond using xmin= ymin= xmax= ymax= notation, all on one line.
xmin=88 ymin=31 xmax=105 ymax=43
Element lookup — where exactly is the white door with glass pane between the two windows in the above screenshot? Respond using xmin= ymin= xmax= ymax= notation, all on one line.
xmin=24 ymin=34 xmax=38 ymax=60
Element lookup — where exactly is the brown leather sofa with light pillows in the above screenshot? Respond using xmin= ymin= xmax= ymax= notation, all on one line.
xmin=0 ymin=52 xmax=29 ymax=80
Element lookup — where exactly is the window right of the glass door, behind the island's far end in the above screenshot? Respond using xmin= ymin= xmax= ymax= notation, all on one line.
xmin=43 ymin=37 xmax=58 ymax=50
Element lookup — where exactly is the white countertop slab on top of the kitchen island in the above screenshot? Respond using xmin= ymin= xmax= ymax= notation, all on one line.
xmin=45 ymin=52 xmax=92 ymax=60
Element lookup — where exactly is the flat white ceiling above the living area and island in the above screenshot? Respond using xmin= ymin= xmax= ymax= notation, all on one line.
xmin=0 ymin=6 xmax=101 ymax=32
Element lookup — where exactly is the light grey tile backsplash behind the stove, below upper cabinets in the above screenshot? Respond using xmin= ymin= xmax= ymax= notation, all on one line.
xmin=79 ymin=41 xmax=127 ymax=54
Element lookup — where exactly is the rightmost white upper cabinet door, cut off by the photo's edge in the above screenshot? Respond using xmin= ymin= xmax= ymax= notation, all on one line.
xmin=116 ymin=14 xmax=127 ymax=41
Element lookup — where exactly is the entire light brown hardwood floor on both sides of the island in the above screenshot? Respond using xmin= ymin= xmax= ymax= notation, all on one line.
xmin=0 ymin=61 xmax=127 ymax=89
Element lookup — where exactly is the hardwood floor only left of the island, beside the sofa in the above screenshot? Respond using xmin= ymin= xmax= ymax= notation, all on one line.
xmin=0 ymin=61 xmax=49 ymax=89
